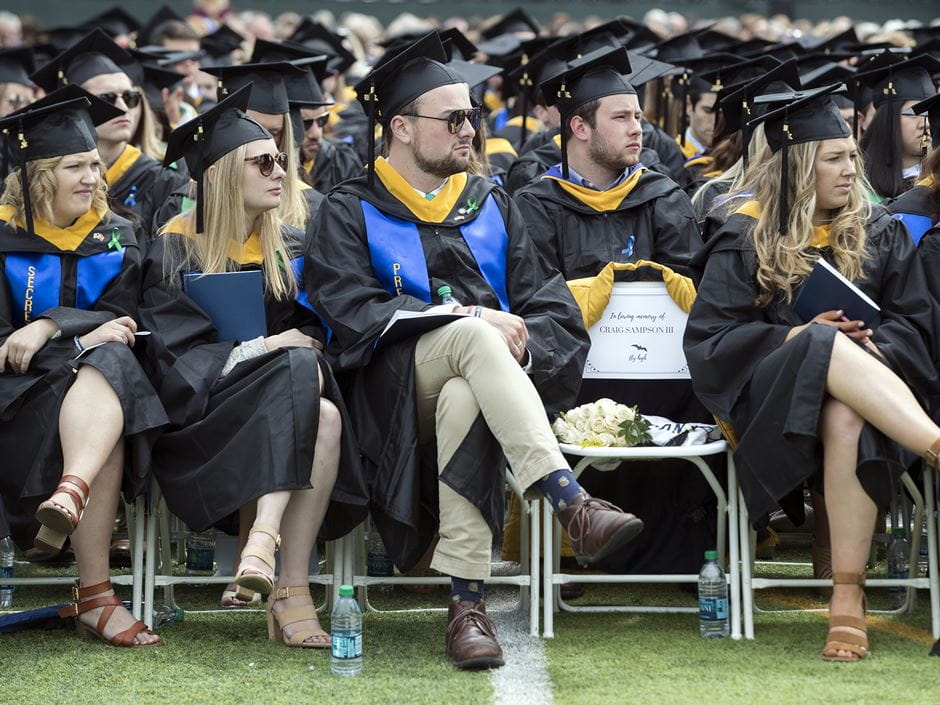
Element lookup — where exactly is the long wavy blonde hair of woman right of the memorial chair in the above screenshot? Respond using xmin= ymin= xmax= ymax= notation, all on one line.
xmin=750 ymin=142 xmax=871 ymax=307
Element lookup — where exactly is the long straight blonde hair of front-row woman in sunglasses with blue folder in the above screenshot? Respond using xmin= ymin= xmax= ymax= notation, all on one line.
xmin=159 ymin=144 xmax=297 ymax=300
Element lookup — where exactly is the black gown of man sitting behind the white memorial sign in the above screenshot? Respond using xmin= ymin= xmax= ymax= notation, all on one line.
xmin=514 ymin=171 xmax=702 ymax=280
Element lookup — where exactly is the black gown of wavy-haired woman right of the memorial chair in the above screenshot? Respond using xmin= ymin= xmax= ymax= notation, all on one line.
xmin=684 ymin=209 xmax=937 ymax=524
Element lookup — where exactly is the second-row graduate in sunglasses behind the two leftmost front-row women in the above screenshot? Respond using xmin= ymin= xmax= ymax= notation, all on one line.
xmin=31 ymin=29 xmax=189 ymax=247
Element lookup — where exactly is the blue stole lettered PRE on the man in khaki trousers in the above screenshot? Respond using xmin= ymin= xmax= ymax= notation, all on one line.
xmin=360 ymin=198 xmax=509 ymax=311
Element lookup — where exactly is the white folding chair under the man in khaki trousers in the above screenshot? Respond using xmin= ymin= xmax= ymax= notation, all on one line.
xmin=346 ymin=470 xmax=541 ymax=636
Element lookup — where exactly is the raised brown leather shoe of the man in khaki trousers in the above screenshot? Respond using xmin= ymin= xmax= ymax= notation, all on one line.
xmin=557 ymin=493 xmax=643 ymax=565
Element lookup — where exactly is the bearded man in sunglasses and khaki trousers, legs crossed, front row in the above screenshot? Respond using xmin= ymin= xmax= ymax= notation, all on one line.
xmin=305 ymin=33 xmax=643 ymax=668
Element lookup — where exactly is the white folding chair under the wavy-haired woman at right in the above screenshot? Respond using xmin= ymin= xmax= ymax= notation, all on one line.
xmin=738 ymin=463 xmax=940 ymax=639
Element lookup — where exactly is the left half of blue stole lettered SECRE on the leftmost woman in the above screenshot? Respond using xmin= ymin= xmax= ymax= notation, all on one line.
xmin=5 ymin=252 xmax=62 ymax=326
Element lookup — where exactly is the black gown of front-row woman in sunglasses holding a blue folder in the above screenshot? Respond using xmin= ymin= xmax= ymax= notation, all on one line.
xmin=141 ymin=226 xmax=365 ymax=539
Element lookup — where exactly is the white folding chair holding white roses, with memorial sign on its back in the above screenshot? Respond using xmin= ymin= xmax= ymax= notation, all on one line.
xmin=542 ymin=278 xmax=741 ymax=639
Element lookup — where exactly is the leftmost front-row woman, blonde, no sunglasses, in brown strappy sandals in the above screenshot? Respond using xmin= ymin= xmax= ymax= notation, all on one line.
xmin=0 ymin=86 xmax=167 ymax=647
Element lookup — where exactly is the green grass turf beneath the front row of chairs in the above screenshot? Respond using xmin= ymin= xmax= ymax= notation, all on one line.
xmin=0 ymin=554 xmax=940 ymax=705
